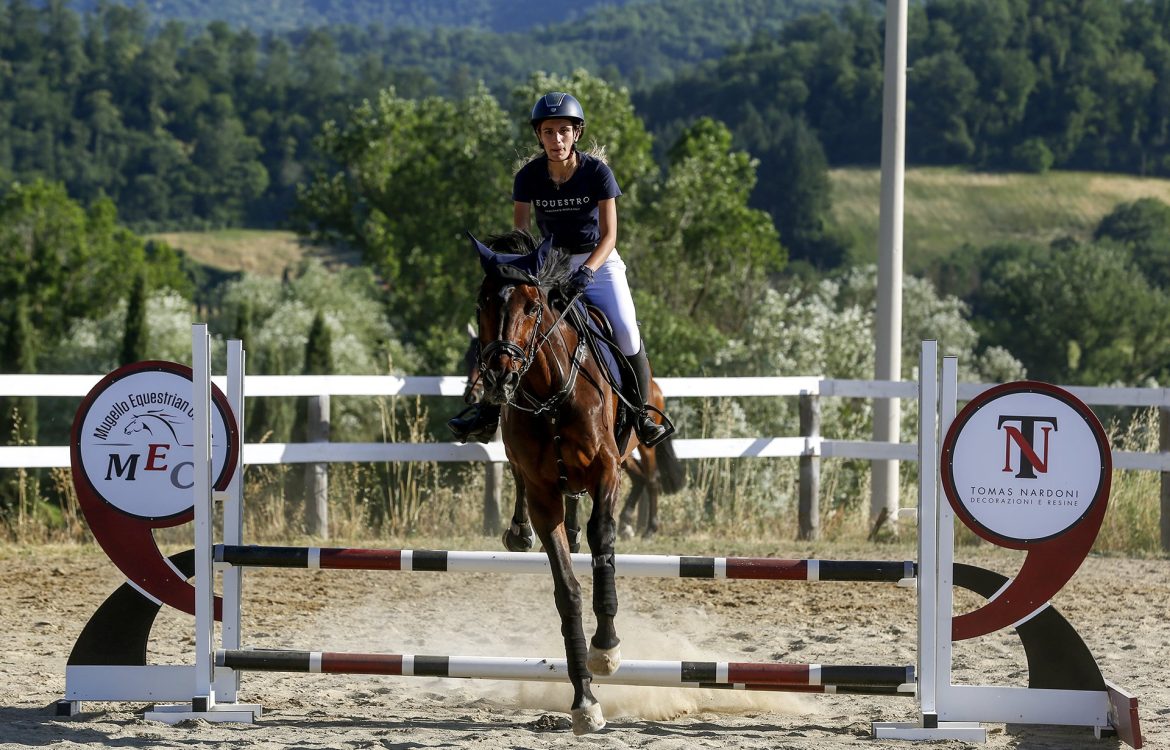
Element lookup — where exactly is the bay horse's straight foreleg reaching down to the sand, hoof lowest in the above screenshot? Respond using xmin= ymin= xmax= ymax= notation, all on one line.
xmin=530 ymin=489 xmax=605 ymax=735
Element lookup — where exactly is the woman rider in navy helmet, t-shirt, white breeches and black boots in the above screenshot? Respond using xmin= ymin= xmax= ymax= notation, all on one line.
xmin=447 ymin=91 xmax=667 ymax=446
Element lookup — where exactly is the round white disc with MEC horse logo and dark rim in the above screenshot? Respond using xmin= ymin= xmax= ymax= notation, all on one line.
xmin=73 ymin=362 xmax=239 ymax=520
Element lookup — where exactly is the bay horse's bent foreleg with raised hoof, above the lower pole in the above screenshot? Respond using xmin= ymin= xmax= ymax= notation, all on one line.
xmin=587 ymin=468 xmax=621 ymax=675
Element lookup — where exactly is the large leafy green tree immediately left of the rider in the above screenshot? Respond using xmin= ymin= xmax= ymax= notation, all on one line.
xmin=298 ymin=83 xmax=517 ymax=372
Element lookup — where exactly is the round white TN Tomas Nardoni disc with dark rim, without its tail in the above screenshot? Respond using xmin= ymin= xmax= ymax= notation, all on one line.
xmin=942 ymin=380 xmax=1113 ymax=548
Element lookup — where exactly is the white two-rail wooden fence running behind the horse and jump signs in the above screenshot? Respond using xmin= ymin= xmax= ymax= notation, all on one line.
xmin=0 ymin=374 xmax=1170 ymax=542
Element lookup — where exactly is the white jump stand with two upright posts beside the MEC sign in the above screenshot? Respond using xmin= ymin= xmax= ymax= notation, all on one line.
xmin=144 ymin=324 xmax=262 ymax=724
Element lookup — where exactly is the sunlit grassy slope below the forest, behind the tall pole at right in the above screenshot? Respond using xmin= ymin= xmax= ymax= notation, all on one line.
xmin=831 ymin=168 xmax=1170 ymax=273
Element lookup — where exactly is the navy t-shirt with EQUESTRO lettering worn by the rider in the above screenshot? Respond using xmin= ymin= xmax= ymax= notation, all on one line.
xmin=512 ymin=151 xmax=621 ymax=252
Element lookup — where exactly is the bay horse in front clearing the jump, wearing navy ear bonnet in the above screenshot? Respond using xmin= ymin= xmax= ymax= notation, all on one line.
xmin=470 ymin=232 xmax=650 ymax=735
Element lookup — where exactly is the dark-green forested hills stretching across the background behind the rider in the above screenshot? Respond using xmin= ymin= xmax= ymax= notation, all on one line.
xmin=13 ymin=0 xmax=1170 ymax=267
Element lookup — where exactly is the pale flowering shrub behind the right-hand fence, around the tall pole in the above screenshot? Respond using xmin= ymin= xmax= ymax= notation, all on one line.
xmin=670 ymin=266 xmax=1025 ymax=528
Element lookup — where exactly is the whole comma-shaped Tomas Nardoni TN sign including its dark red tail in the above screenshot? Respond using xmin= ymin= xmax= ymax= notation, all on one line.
xmin=941 ymin=380 xmax=1113 ymax=640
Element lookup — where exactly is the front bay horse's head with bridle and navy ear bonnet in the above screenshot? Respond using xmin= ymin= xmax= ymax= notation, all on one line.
xmin=472 ymin=232 xmax=569 ymax=404
